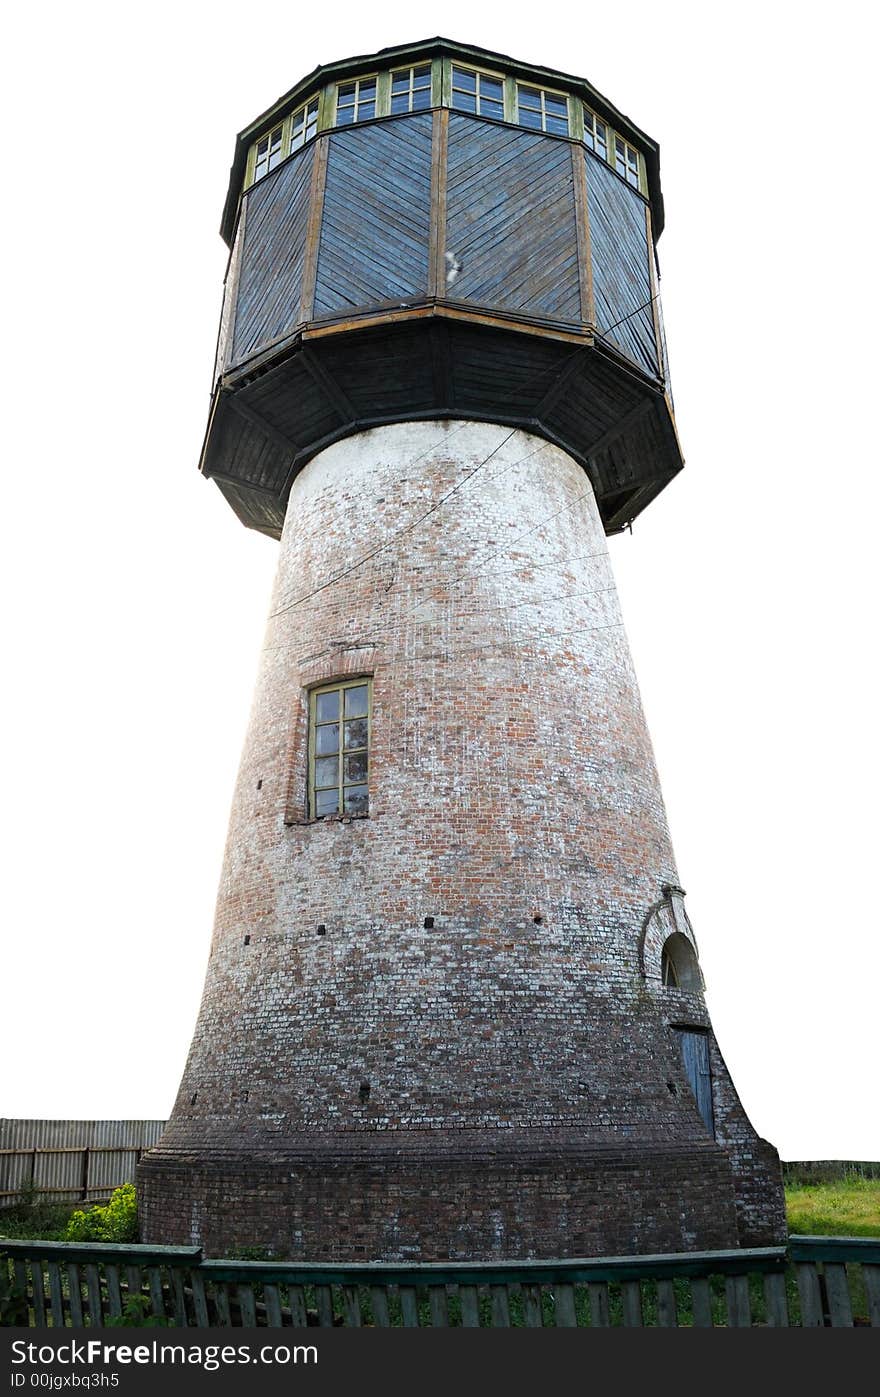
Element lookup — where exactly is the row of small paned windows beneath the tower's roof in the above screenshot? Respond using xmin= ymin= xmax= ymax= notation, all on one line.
xmin=246 ymin=60 xmax=645 ymax=191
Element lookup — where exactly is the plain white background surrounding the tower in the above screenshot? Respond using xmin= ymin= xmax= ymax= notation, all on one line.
xmin=0 ymin=0 xmax=880 ymax=1160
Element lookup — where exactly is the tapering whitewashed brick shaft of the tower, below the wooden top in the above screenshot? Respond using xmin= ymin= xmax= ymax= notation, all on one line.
xmin=141 ymin=422 xmax=781 ymax=1257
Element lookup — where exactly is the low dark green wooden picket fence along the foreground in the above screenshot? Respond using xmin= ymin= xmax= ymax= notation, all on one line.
xmin=0 ymin=1236 xmax=880 ymax=1329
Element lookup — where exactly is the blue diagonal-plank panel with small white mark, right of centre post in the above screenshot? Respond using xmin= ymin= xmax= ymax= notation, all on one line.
xmin=447 ymin=113 xmax=584 ymax=323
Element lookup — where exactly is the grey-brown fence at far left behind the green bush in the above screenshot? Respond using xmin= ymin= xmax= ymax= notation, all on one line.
xmin=0 ymin=1120 xmax=165 ymax=1207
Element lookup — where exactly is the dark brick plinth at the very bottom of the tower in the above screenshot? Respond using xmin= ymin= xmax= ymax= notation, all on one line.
xmin=138 ymin=1134 xmax=778 ymax=1261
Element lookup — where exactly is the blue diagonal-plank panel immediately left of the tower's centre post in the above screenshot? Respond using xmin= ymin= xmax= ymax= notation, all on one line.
xmin=314 ymin=113 xmax=432 ymax=319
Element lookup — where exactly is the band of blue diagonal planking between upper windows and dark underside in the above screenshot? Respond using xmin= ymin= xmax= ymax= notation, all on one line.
xmin=218 ymin=109 xmax=662 ymax=379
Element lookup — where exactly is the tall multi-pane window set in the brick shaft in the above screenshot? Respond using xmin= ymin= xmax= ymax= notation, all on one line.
xmin=309 ymin=675 xmax=373 ymax=820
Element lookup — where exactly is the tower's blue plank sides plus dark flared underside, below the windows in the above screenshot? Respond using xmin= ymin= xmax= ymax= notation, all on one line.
xmin=201 ymin=106 xmax=682 ymax=535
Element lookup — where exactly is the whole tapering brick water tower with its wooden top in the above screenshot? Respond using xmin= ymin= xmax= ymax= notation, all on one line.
xmin=140 ymin=39 xmax=784 ymax=1260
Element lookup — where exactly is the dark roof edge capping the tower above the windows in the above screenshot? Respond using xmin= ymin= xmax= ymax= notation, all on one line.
xmin=221 ymin=38 xmax=663 ymax=243
